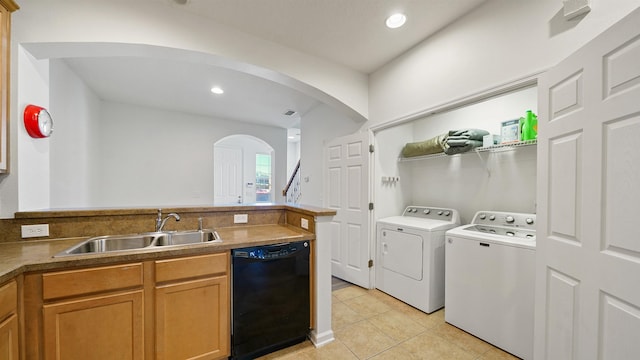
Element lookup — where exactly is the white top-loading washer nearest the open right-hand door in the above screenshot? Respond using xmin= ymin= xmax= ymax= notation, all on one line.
xmin=445 ymin=211 xmax=536 ymax=359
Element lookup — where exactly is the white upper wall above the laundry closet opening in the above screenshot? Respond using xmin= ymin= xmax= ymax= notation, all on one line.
xmin=369 ymin=0 xmax=640 ymax=126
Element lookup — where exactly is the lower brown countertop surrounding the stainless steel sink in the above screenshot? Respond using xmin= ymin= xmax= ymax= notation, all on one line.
xmin=0 ymin=224 xmax=315 ymax=284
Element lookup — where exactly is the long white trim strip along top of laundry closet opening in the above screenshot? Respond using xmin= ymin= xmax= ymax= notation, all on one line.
xmin=369 ymin=70 xmax=546 ymax=134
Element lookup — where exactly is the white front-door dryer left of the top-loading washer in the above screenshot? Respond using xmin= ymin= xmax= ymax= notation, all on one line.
xmin=376 ymin=206 xmax=460 ymax=313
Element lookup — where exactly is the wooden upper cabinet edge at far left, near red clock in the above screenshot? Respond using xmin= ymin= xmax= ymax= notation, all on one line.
xmin=0 ymin=0 xmax=19 ymax=173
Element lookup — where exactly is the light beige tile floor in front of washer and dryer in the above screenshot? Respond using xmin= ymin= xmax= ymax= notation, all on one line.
xmin=260 ymin=285 xmax=517 ymax=360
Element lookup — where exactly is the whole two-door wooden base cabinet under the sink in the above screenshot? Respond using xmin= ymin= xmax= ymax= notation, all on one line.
xmin=23 ymin=252 xmax=231 ymax=360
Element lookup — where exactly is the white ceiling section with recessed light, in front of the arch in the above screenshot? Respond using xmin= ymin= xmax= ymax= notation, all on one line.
xmin=154 ymin=0 xmax=486 ymax=74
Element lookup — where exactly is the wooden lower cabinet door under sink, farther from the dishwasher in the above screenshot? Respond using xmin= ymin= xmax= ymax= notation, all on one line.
xmin=43 ymin=290 xmax=144 ymax=360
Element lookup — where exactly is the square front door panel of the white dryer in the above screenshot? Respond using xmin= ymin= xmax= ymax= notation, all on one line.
xmin=378 ymin=226 xmax=424 ymax=281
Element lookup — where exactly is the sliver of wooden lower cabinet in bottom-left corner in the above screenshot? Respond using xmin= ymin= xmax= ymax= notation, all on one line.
xmin=0 ymin=280 xmax=20 ymax=359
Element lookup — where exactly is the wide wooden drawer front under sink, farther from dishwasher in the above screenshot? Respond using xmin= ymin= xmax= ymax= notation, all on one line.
xmin=42 ymin=263 xmax=143 ymax=300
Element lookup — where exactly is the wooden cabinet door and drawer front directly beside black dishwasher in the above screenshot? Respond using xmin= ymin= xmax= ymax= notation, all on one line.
xmin=155 ymin=253 xmax=231 ymax=359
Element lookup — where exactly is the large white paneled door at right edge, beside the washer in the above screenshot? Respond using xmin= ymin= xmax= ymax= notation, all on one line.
xmin=534 ymin=9 xmax=640 ymax=360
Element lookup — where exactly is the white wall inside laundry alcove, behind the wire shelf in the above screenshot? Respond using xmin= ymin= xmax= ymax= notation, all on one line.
xmin=374 ymin=87 xmax=537 ymax=222
